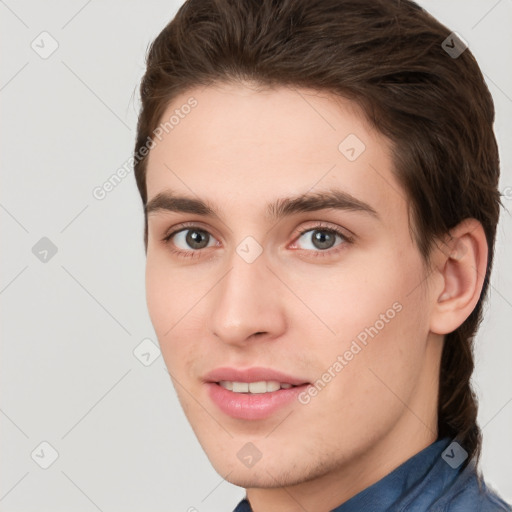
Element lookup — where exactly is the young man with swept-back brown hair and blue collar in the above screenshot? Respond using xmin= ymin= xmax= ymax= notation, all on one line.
xmin=134 ymin=0 xmax=510 ymax=512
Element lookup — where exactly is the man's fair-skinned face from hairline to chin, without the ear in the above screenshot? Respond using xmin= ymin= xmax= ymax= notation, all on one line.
xmin=146 ymin=84 xmax=439 ymax=487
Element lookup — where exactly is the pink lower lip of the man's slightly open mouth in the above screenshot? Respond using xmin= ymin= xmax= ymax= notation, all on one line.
xmin=206 ymin=382 xmax=309 ymax=420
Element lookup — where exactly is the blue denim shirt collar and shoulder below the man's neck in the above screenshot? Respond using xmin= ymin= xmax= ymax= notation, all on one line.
xmin=233 ymin=438 xmax=512 ymax=512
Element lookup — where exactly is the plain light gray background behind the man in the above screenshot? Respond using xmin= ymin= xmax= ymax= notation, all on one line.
xmin=0 ymin=0 xmax=512 ymax=512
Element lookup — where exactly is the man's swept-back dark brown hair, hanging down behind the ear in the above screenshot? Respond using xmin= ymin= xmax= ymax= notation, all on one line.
xmin=134 ymin=0 xmax=501 ymax=463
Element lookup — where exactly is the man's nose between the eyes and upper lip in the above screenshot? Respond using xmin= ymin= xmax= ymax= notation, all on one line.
xmin=209 ymin=245 xmax=286 ymax=347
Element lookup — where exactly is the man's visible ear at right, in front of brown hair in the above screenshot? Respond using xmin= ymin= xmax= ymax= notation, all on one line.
xmin=430 ymin=219 xmax=488 ymax=334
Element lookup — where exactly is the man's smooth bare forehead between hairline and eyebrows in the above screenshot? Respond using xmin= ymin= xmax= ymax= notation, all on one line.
xmin=143 ymin=84 xmax=405 ymax=220
